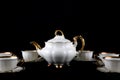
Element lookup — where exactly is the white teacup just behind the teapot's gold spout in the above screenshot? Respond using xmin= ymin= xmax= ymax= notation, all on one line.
xmin=22 ymin=50 xmax=39 ymax=62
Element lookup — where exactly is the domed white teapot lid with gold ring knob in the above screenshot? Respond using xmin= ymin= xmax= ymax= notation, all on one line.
xmin=47 ymin=30 xmax=71 ymax=42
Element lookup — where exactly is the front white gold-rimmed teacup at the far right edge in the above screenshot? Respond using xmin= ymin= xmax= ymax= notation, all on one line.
xmin=102 ymin=56 xmax=120 ymax=73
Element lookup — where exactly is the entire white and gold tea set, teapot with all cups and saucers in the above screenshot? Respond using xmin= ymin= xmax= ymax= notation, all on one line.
xmin=0 ymin=30 xmax=120 ymax=73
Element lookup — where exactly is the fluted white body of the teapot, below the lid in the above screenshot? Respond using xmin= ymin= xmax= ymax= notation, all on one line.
xmin=38 ymin=42 xmax=77 ymax=65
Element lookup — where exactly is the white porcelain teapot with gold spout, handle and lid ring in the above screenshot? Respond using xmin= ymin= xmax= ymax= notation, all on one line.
xmin=31 ymin=30 xmax=85 ymax=68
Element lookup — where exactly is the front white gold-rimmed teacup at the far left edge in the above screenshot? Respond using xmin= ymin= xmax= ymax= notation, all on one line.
xmin=0 ymin=56 xmax=18 ymax=72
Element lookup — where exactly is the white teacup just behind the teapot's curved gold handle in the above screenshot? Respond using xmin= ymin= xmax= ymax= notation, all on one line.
xmin=77 ymin=50 xmax=94 ymax=61
